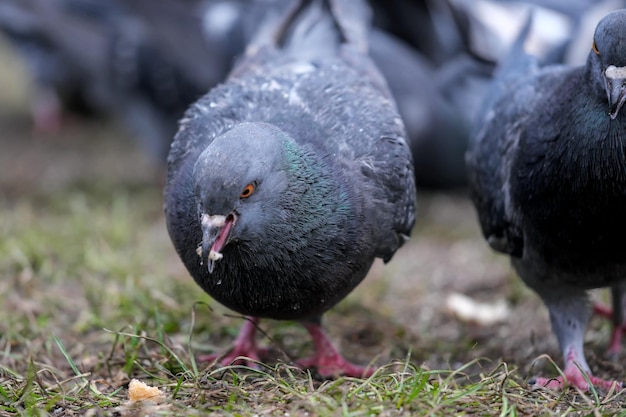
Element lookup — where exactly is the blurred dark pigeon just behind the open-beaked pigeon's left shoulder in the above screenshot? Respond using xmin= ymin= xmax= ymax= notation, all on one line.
xmin=117 ymin=0 xmax=251 ymax=162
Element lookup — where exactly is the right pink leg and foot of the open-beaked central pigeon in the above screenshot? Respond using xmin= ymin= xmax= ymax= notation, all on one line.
xmin=298 ymin=323 xmax=374 ymax=378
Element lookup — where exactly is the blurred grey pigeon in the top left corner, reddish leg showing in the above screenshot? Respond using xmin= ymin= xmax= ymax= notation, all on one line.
xmin=0 ymin=0 xmax=117 ymax=132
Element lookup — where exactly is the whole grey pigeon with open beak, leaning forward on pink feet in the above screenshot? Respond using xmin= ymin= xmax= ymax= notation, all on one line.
xmin=164 ymin=0 xmax=416 ymax=377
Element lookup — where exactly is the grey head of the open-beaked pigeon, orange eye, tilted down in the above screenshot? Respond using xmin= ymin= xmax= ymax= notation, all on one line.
xmin=193 ymin=123 xmax=304 ymax=273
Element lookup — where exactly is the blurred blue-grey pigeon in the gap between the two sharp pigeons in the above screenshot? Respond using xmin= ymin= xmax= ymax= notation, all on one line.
xmin=369 ymin=29 xmax=472 ymax=189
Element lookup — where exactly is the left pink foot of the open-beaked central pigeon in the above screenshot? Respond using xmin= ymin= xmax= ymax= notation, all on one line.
xmin=198 ymin=317 xmax=267 ymax=368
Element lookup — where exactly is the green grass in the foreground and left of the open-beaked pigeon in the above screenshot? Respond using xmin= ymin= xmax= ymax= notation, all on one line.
xmin=0 ymin=184 xmax=626 ymax=416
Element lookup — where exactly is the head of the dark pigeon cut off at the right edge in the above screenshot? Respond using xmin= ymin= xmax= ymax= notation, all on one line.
xmin=589 ymin=9 xmax=626 ymax=119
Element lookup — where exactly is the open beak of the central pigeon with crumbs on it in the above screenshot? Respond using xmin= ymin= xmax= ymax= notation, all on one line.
xmin=199 ymin=213 xmax=236 ymax=274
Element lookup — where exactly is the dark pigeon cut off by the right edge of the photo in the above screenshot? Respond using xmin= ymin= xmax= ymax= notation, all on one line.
xmin=466 ymin=9 xmax=626 ymax=390
